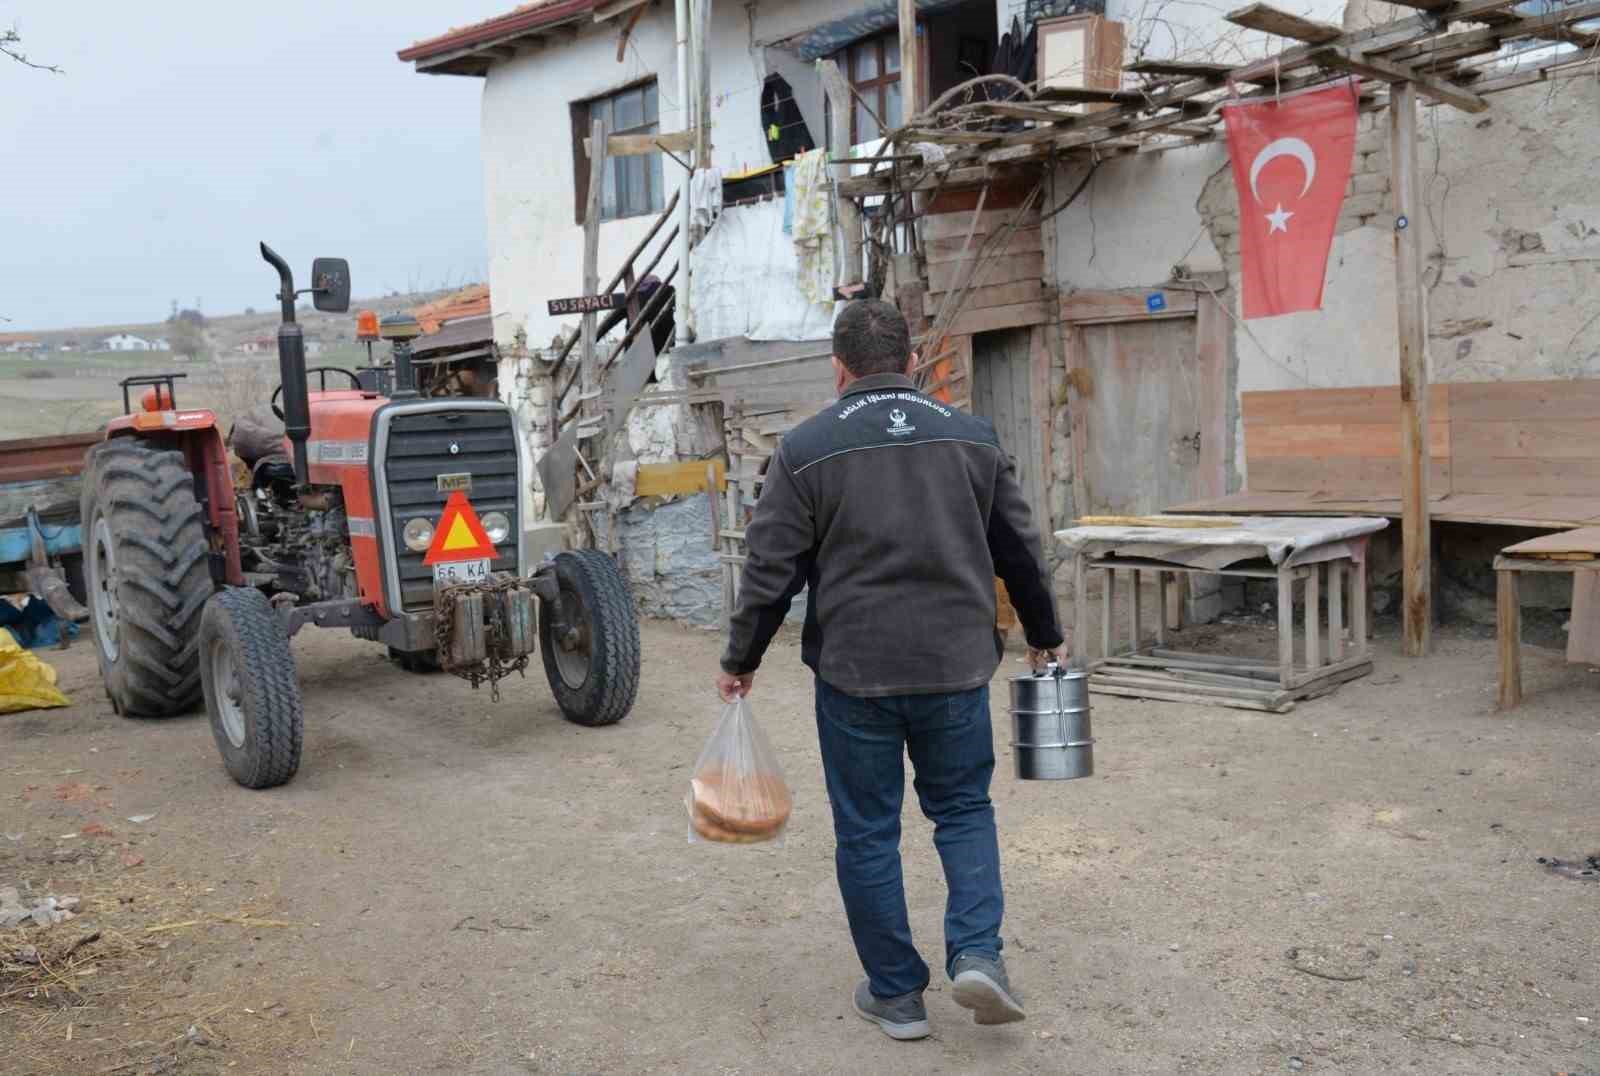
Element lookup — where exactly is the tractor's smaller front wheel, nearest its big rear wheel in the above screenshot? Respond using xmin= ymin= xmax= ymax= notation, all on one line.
xmin=200 ymin=586 xmax=306 ymax=788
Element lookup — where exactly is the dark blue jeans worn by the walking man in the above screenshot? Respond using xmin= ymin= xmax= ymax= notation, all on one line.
xmin=816 ymin=679 xmax=1005 ymax=998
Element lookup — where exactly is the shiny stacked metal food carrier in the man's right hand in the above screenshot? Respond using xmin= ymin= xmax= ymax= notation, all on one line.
xmin=1011 ymin=664 xmax=1094 ymax=781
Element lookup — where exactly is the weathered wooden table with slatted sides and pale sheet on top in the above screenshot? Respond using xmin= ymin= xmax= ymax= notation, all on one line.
xmin=1058 ymin=520 xmax=1382 ymax=713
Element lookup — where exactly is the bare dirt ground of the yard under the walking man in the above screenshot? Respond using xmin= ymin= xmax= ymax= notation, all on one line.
xmin=0 ymin=624 xmax=1600 ymax=1076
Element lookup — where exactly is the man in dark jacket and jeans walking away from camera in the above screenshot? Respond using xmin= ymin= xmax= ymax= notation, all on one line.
xmin=717 ymin=299 xmax=1066 ymax=1039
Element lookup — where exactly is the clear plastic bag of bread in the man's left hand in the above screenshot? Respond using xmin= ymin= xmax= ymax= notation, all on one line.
xmin=683 ymin=697 xmax=794 ymax=844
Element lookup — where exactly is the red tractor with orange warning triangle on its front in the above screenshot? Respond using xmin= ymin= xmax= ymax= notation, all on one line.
xmin=82 ymin=243 xmax=638 ymax=788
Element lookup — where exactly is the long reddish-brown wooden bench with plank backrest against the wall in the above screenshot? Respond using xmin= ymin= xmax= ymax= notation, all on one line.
xmin=1168 ymin=379 xmax=1600 ymax=528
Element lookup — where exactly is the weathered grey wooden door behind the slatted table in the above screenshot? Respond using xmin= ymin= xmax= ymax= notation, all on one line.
xmin=1078 ymin=317 xmax=1218 ymax=516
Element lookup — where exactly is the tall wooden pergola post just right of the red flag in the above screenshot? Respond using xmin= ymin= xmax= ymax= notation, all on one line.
xmin=1389 ymin=82 xmax=1434 ymax=658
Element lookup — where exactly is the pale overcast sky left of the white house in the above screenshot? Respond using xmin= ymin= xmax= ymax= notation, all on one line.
xmin=0 ymin=0 xmax=515 ymax=331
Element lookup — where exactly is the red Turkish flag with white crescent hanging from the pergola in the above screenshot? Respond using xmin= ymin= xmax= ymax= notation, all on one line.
xmin=1222 ymin=78 xmax=1355 ymax=317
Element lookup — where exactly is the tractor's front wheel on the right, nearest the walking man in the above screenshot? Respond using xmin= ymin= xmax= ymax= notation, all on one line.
xmin=539 ymin=549 xmax=638 ymax=725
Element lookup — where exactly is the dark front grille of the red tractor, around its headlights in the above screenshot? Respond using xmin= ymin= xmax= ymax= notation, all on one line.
xmin=379 ymin=405 xmax=522 ymax=612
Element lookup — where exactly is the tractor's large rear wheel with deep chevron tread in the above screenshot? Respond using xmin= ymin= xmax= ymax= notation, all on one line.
xmin=80 ymin=437 xmax=214 ymax=717
